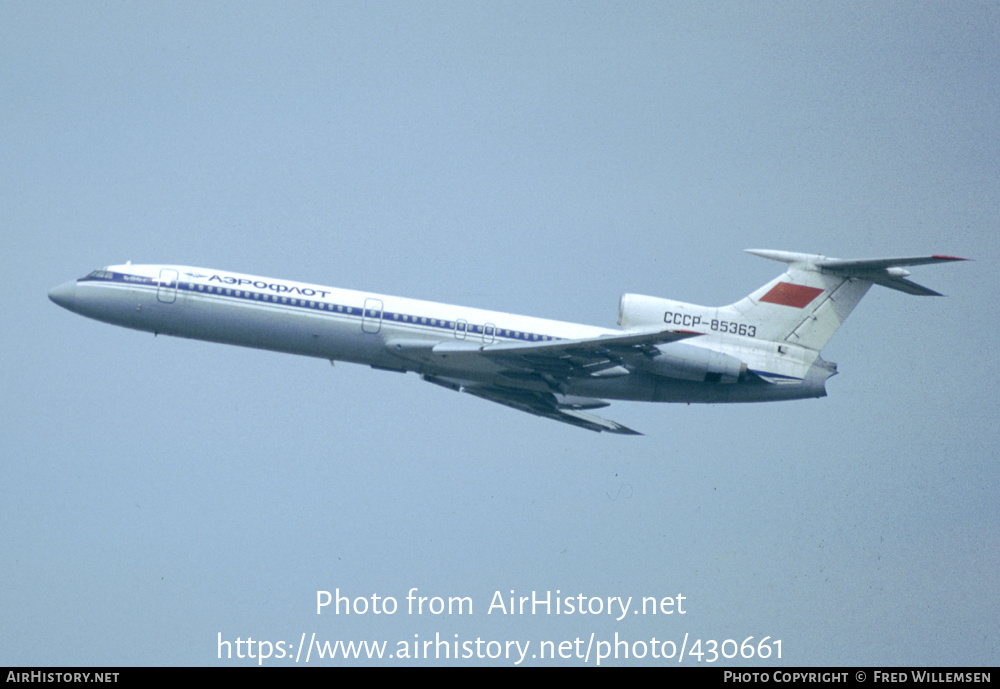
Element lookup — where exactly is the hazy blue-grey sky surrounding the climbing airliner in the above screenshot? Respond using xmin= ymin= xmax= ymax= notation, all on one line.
xmin=0 ymin=1 xmax=1000 ymax=665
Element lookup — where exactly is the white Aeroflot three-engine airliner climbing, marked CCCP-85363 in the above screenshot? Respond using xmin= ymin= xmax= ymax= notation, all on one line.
xmin=49 ymin=249 xmax=966 ymax=435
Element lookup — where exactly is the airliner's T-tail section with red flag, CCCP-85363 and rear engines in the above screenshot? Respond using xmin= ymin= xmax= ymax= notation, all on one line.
xmin=618 ymin=249 xmax=965 ymax=401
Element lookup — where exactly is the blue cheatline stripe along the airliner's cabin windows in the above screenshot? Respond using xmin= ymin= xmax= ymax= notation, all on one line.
xmin=78 ymin=271 xmax=563 ymax=342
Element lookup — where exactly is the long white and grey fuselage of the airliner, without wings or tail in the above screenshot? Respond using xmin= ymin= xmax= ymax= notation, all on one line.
xmin=50 ymin=265 xmax=830 ymax=402
